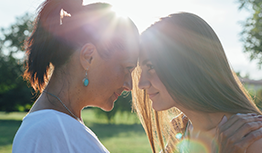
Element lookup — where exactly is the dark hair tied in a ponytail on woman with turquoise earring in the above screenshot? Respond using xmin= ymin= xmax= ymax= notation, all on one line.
xmin=24 ymin=0 xmax=139 ymax=91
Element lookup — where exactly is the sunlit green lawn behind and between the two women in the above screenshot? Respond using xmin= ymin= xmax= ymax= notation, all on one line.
xmin=0 ymin=109 xmax=151 ymax=153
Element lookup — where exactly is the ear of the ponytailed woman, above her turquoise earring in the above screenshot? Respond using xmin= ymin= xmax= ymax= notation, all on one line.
xmin=80 ymin=43 xmax=97 ymax=70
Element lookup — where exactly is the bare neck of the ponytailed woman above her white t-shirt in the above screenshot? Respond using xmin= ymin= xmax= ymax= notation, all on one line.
xmin=30 ymin=69 xmax=84 ymax=120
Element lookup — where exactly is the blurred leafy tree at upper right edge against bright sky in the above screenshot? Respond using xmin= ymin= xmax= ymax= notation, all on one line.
xmin=238 ymin=0 xmax=262 ymax=68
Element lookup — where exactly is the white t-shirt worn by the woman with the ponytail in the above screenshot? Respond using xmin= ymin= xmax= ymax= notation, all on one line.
xmin=12 ymin=109 xmax=109 ymax=153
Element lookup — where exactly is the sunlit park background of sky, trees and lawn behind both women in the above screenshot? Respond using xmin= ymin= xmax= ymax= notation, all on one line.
xmin=0 ymin=0 xmax=262 ymax=153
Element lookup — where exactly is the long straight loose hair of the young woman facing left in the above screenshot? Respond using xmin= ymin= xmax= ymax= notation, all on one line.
xmin=133 ymin=13 xmax=261 ymax=152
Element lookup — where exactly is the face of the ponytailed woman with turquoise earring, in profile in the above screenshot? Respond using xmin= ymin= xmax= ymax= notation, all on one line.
xmin=90 ymin=44 xmax=139 ymax=111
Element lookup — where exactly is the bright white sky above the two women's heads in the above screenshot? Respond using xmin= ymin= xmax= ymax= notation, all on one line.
xmin=0 ymin=0 xmax=262 ymax=79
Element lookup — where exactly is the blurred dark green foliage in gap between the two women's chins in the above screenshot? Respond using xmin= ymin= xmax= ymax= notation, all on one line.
xmin=93 ymin=91 xmax=132 ymax=123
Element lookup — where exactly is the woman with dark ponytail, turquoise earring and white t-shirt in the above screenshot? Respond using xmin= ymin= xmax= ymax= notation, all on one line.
xmin=13 ymin=0 xmax=139 ymax=153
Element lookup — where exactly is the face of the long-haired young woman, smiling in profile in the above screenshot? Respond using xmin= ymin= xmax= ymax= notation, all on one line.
xmin=138 ymin=52 xmax=175 ymax=111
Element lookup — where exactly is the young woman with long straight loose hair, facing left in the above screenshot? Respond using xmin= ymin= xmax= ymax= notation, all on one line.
xmin=133 ymin=13 xmax=262 ymax=153
